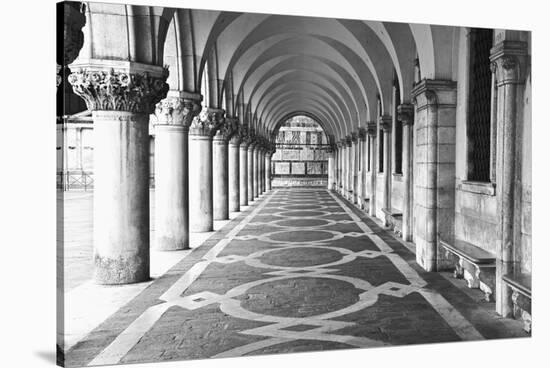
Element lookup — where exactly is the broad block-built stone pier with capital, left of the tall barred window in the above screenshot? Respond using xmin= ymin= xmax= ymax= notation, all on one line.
xmin=412 ymin=80 xmax=456 ymax=271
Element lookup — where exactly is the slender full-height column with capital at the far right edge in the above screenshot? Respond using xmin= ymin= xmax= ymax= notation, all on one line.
xmin=491 ymin=39 xmax=528 ymax=317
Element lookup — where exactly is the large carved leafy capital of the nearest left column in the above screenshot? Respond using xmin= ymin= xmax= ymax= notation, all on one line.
xmin=68 ymin=68 xmax=168 ymax=114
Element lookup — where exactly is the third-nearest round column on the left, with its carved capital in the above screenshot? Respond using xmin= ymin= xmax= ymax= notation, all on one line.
xmin=189 ymin=108 xmax=225 ymax=233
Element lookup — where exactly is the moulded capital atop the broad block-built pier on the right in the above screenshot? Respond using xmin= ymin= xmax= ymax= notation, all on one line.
xmin=411 ymin=79 xmax=456 ymax=111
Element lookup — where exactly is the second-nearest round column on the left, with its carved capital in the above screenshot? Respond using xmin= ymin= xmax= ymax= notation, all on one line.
xmin=154 ymin=91 xmax=201 ymax=250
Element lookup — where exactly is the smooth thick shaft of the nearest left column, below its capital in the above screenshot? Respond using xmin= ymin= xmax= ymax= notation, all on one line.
xmin=92 ymin=111 xmax=149 ymax=284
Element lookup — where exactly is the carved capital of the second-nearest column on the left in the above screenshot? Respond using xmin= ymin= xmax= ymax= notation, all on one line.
xmin=154 ymin=96 xmax=201 ymax=128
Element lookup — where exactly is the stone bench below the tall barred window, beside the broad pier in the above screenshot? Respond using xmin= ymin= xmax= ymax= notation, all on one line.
xmin=439 ymin=240 xmax=496 ymax=302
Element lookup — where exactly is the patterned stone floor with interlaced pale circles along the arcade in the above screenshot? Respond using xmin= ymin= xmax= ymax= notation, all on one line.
xmin=61 ymin=189 xmax=527 ymax=366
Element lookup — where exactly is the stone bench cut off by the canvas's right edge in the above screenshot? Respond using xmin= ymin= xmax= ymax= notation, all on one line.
xmin=502 ymin=273 xmax=531 ymax=333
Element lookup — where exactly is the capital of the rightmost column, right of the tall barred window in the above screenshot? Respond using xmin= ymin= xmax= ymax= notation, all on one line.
xmin=489 ymin=40 xmax=528 ymax=85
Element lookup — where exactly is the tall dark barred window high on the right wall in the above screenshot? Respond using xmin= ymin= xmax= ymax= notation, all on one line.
xmin=466 ymin=28 xmax=493 ymax=182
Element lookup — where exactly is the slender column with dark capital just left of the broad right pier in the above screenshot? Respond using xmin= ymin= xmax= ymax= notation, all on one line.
xmin=397 ymin=104 xmax=414 ymax=241
